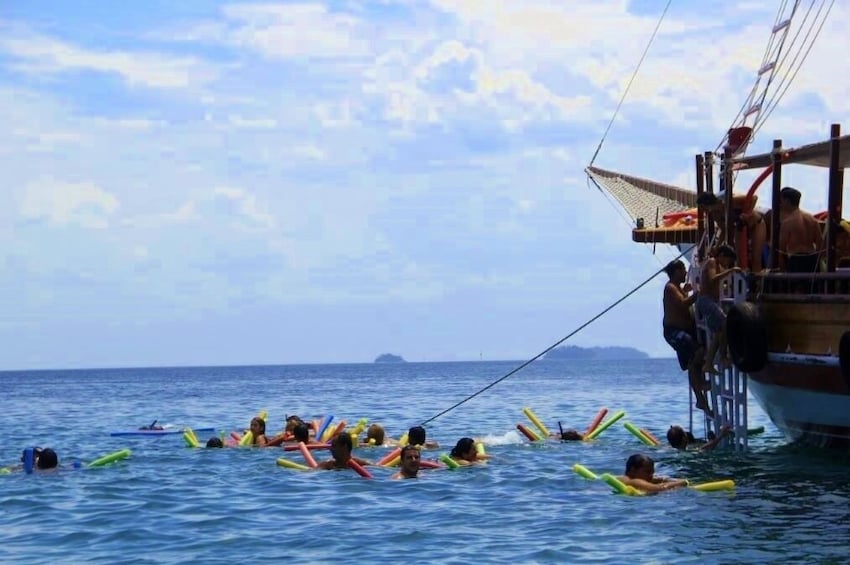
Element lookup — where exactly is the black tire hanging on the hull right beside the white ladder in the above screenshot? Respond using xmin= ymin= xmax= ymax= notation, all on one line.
xmin=726 ymin=302 xmax=768 ymax=373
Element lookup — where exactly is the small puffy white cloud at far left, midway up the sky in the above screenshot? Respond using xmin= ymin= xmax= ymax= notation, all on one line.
xmin=19 ymin=180 xmax=118 ymax=229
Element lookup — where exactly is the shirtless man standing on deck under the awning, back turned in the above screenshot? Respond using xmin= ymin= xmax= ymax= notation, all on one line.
xmin=779 ymin=186 xmax=823 ymax=273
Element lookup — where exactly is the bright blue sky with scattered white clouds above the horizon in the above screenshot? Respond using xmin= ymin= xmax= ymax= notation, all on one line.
xmin=0 ymin=0 xmax=850 ymax=369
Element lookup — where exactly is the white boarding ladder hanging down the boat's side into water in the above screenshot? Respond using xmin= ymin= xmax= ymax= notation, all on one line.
xmin=688 ymin=271 xmax=747 ymax=451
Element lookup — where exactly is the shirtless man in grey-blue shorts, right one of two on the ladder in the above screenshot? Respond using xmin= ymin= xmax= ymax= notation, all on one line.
xmin=696 ymin=244 xmax=741 ymax=375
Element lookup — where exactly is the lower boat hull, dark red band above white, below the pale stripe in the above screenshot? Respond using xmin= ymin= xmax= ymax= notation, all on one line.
xmin=748 ymin=358 xmax=850 ymax=449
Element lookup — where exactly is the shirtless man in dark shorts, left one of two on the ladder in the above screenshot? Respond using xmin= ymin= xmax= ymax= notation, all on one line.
xmin=662 ymin=260 xmax=708 ymax=410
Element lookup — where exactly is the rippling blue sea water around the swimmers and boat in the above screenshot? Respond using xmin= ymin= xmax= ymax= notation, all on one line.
xmin=0 ymin=359 xmax=850 ymax=563
